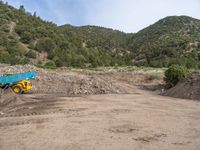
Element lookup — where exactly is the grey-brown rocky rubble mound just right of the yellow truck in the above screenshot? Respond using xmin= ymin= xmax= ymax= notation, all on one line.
xmin=32 ymin=72 xmax=127 ymax=95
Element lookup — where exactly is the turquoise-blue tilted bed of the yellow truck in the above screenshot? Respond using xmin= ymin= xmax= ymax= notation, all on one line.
xmin=0 ymin=71 xmax=36 ymax=84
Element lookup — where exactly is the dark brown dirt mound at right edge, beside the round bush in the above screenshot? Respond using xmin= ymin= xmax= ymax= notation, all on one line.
xmin=164 ymin=73 xmax=200 ymax=100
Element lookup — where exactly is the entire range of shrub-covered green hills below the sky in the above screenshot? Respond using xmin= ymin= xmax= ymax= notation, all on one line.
xmin=0 ymin=1 xmax=200 ymax=68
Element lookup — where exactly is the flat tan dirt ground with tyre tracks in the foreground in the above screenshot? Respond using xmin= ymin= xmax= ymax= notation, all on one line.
xmin=0 ymin=90 xmax=200 ymax=150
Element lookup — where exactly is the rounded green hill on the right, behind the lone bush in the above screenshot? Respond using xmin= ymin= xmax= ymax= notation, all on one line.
xmin=128 ymin=16 xmax=200 ymax=68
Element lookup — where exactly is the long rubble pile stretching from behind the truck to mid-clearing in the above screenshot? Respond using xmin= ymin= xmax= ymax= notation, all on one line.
xmin=0 ymin=65 xmax=134 ymax=95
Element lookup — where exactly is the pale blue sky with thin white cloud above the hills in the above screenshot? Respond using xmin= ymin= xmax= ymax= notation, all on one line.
xmin=4 ymin=0 xmax=200 ymax=32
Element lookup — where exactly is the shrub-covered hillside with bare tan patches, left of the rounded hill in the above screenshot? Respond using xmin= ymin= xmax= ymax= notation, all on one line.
xmin=0 ymin=3 xmax=131 ymax=67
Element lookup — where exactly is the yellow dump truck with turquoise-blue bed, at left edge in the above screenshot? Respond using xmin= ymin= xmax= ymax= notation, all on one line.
xmin=0 ymin=71 xmax=36 ymax=94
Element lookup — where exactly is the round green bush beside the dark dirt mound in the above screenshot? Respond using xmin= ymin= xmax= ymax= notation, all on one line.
xmin=164 ymin=65 xmax=189 ymax=86
